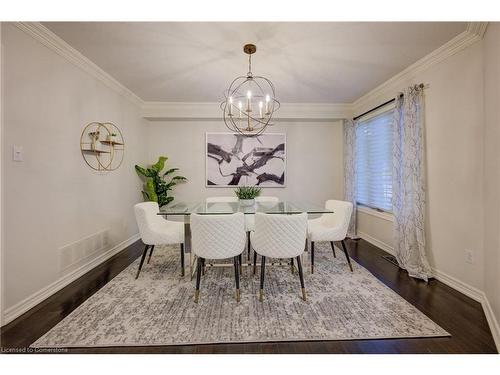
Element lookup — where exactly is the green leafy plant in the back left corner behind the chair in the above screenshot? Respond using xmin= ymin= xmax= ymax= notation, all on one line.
xmin=135 ymin=156 xmax=187 ymax=207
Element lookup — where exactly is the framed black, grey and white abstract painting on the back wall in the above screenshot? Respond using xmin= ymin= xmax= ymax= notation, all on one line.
xmin=205 ymin=132 xmax=287 ymax=188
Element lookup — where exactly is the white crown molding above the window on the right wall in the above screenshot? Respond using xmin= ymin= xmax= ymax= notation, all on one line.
xmin=352 ymin=22 xmax=488 ymax=113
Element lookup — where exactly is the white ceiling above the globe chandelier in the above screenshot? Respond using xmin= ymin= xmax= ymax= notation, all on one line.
xmin=44 ymin=22 xmax=467 ymax=103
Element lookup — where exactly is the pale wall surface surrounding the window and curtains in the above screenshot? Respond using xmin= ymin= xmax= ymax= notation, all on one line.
xmin=355 ymin=42 xmax=484 ymax=290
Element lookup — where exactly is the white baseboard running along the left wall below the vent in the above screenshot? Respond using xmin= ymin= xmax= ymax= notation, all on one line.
xmin=2 ymin=234 xmax=140 ymax=325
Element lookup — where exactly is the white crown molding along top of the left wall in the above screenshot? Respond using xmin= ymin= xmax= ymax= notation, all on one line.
xmin=13 ymin=22 xmax=143 ymax=105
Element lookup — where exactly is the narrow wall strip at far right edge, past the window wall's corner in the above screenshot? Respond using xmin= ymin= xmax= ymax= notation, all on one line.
xmin=483 ymin=23 xmax=500 ymax=340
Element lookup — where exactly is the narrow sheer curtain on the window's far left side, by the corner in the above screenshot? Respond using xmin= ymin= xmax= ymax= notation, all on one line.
xmin=344 ymin=119 xmax=357 ymax=238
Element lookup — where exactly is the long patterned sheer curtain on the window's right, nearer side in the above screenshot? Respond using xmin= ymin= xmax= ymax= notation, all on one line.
xmin=392 ymin=86 xmax=432 ymax=281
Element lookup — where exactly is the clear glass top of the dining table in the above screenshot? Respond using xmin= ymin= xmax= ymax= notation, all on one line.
xmin=158 ymin=201 xmax=333 ymax=215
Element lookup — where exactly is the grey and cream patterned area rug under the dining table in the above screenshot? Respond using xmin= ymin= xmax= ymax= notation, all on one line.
xmin=32 ymin=243 xmax=449 ymax=347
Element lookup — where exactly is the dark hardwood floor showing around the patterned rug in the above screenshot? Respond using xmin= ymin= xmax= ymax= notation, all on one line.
xmin=1 ymin=240 xmax=497 ymax=353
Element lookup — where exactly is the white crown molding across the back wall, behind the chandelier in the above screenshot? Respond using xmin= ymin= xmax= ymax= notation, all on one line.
xmin=142 ymin=102 xmax=353 ymax=121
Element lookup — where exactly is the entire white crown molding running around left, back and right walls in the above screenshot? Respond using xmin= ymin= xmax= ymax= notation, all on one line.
xmin=14 ymin=22 xmax=488 ymax=121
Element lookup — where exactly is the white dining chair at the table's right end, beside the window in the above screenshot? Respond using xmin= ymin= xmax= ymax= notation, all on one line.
xmin=307 ymin=200 xmax=353 ymax=273
